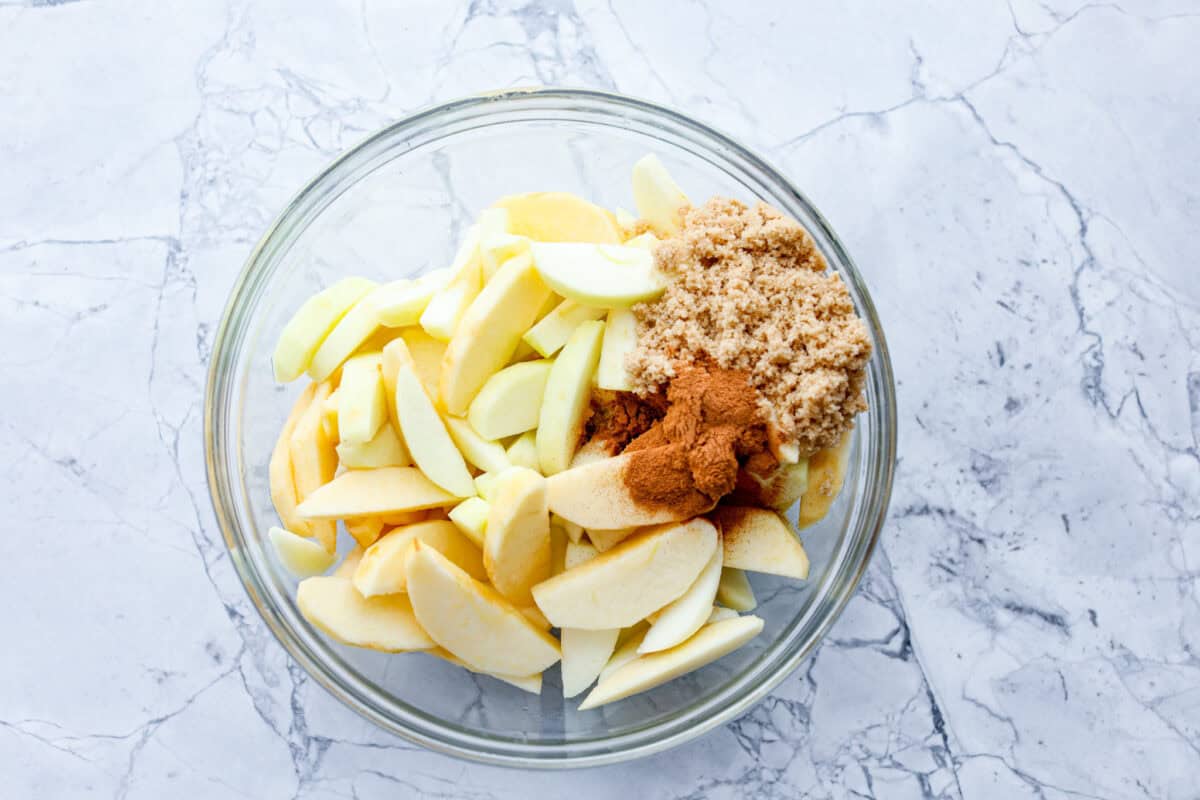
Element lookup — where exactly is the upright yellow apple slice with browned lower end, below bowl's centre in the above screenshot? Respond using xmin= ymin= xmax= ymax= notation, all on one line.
xmin=484 ymin=467 xmax=551 ymax=606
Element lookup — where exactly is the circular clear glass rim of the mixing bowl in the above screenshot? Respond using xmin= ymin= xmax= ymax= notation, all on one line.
xmin=204 ymin=88 xmax=896 ymax=769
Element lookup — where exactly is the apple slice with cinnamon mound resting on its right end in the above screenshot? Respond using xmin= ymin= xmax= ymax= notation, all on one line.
xmin=549 ymin=451 xmax=700 ymax=530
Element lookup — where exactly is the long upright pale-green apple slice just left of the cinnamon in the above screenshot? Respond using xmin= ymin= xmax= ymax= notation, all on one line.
xmin=536 ymin=320 xmax=611 ymax=474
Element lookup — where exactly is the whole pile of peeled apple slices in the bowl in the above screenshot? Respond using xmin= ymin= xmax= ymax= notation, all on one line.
xmin=269 ymin=156 xmax=845 ymax=709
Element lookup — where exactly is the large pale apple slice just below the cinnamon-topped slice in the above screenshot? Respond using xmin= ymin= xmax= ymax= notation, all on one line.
xmin=533 ymin=518 xmax=718 ymax=631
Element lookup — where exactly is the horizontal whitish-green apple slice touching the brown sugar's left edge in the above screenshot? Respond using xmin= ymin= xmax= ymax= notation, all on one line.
xmin=529 ymin=242 xmax=667 ymax=308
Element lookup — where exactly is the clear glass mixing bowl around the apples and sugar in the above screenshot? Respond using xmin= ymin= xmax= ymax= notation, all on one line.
xmin=204 ymin=90 xmax=895 ymax=768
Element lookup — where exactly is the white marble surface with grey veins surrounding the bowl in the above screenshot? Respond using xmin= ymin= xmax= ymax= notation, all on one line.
xmin=0 ymin=0 xmax=1200 ymax=800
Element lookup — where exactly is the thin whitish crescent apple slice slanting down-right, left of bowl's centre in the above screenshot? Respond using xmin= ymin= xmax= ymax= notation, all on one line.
xmin=388 ymin=339 xmax=475 ymax=498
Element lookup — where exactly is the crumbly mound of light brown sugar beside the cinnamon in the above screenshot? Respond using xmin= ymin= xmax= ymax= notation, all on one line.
xmin=628 ymin=198 xmax=871 ymax=453
